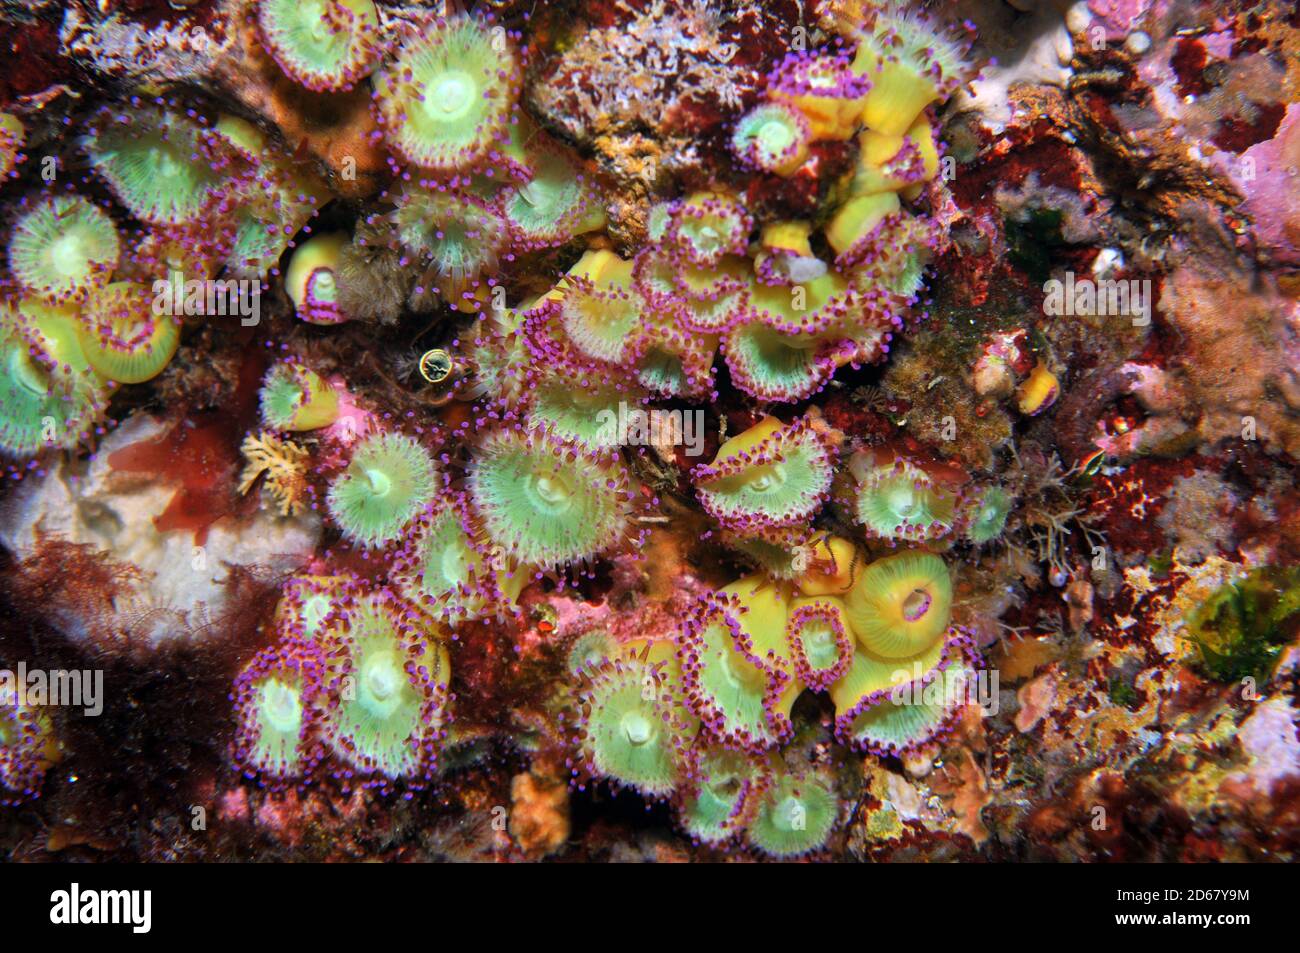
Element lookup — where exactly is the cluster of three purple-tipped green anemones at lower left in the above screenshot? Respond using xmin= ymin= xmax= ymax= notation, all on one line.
xmin=230 ymin=576 xmax=451 ymax=785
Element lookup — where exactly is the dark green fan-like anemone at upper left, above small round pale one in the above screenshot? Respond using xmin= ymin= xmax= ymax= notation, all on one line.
xmin=86 ymin=105 xmax=235 ymax=225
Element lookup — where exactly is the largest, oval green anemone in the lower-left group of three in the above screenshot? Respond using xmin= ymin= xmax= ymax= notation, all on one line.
xmin=322 ymin=589 xmax=451 ymax=780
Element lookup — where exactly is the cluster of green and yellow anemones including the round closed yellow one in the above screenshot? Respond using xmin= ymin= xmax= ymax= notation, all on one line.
xmin=575 ymin=538 xmax=972 ymax=857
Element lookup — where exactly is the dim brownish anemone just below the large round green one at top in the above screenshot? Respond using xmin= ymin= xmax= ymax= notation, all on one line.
xmin=391 ymin=189 xmax=507 ymax=293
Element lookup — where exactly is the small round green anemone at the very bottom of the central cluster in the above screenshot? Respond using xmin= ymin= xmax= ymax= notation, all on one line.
xmin=745 ymin=768 xmax=840 ymax=858
